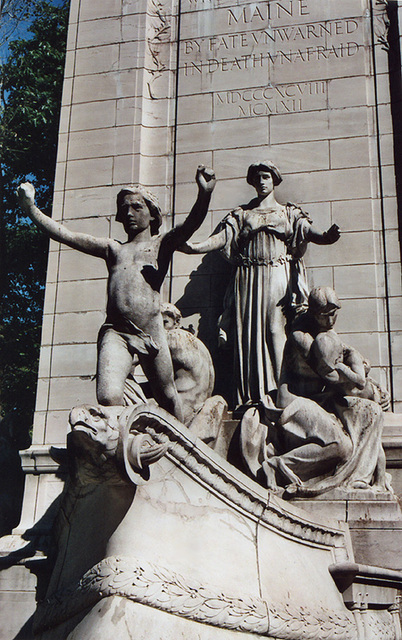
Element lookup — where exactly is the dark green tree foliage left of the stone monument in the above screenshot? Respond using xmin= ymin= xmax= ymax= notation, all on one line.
xmin=0 ymin=0 xmax=69 ymax=428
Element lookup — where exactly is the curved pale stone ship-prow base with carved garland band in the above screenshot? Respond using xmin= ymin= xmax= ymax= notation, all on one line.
xmin=25 ymin=406 xmax=402 ymax=640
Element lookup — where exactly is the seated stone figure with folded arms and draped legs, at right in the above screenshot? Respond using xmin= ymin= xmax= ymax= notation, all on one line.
xmin=241 ymin=287 xmax=389 ymax=496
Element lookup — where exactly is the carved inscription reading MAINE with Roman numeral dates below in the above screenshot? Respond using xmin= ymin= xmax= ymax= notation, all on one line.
xmin=180 ymin=0 xmax=364 ymax=118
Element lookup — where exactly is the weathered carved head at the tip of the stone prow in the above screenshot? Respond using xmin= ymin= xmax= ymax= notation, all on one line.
xmin=69 ymin=404 xmax=123 ymax=453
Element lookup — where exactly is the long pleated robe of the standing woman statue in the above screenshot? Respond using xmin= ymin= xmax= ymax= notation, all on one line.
xmin=216 ymin=201 xmax=311 ymax=405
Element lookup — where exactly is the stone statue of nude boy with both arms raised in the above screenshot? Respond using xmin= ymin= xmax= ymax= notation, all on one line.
xmin=17 ymin=166 xmax=216 ymax=420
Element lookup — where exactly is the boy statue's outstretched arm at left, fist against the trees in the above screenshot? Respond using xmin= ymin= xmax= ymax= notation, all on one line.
xmin=17 ymin=182 xmax=110 ymax=259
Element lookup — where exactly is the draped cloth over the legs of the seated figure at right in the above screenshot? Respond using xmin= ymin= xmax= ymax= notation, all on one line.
xmin=274 ymin=393 xmax=389 ymax=497
